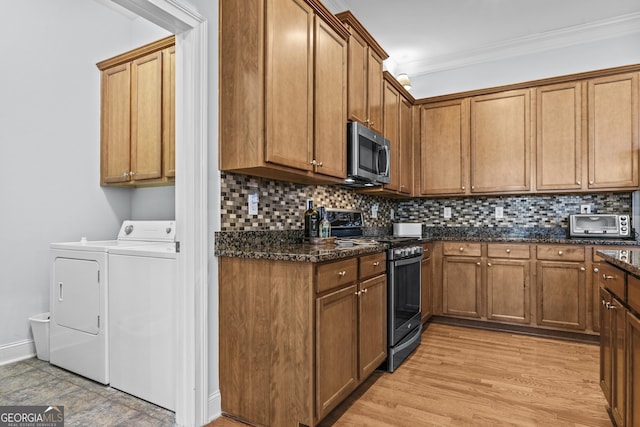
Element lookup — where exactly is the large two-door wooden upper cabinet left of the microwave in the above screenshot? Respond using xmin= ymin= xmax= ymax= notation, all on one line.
xmin=219 ymin=0 xmax=349 ymax=184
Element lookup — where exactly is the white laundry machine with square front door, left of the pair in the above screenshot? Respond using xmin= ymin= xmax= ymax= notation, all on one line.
xmin=49 ymin=221 xmax=175 ymax=384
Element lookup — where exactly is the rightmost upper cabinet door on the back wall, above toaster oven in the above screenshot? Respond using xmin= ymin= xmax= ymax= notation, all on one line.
xmin=589 ymin=73 xmax=638 ymax=188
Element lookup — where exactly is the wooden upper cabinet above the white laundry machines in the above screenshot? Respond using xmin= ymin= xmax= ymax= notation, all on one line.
xmin=97 ymin=36 xmax=175 ymax=187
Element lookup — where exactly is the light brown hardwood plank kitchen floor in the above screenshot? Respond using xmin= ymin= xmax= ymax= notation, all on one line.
xmin=208 ymin=323 xmax=611 ymax=427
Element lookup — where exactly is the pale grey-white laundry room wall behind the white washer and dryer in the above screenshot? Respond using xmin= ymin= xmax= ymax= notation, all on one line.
xmin=0 ymin=0 xmax=173 ymax=363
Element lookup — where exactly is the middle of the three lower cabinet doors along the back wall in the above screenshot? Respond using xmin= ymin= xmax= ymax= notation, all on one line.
xmin=487 ymin=259 xmax=531 ymax=323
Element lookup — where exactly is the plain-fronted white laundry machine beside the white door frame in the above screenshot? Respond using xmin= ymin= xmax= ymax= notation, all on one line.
xmin=109 ymin=241 xmax=177 ymax=411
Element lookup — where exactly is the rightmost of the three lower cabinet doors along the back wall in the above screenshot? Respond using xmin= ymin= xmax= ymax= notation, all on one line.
xmin=536 ymin=261 xmax=586 ymax=330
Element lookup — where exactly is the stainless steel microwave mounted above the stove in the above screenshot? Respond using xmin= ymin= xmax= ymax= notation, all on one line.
xmin=345 ymin=122 xmax=391 ymax=187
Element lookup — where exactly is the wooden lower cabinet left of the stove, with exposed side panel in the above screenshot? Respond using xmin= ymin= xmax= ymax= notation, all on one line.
xmin=218 ymin=253 xmax=387 ymax=426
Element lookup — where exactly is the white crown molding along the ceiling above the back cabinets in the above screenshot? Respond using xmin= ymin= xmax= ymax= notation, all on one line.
xmin=408 ymin=12 xmax=640 ymax=76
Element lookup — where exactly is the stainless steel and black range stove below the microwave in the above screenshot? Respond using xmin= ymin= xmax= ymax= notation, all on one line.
xmin=327 ymin=209 xmax=422 ymax=372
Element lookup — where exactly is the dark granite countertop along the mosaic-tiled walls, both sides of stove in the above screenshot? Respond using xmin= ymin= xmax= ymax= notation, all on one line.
xmin=214 ymin=227 xmax=640 ymax=262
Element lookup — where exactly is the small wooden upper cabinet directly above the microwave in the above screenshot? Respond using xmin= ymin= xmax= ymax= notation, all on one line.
xmin=336 ymin=11 xmax=389 ymax=133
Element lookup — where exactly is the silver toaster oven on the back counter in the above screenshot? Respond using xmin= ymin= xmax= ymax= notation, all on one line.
xmin=569 ymin=214 xmax=631 ymax=239
